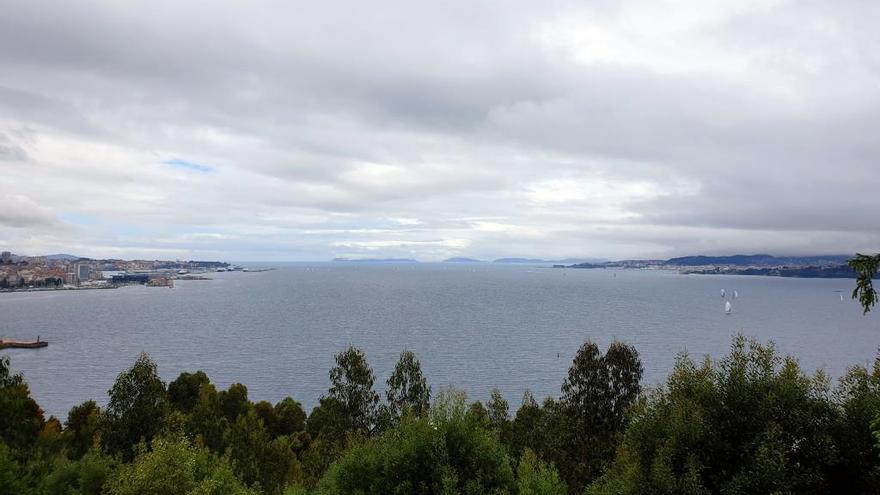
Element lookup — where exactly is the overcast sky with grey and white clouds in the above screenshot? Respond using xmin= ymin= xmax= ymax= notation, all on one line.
xmin=0 ymin=0 xmax=880 ymax=261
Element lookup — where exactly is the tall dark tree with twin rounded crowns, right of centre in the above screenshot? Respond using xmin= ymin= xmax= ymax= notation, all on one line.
xmin=554 ymin=341 xmax=643 ymax=491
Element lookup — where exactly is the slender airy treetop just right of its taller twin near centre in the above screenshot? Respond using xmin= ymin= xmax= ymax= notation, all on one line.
xmin=385 ymin=351 xmax=431 ymax=424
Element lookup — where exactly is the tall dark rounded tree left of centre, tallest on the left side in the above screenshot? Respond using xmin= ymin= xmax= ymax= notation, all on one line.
xmin=103 ymin=352 xmax=168 ymax=459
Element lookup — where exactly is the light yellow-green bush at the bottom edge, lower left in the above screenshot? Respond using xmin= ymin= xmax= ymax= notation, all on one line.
xmin=105 ymin=438 xmax=256 ymax=495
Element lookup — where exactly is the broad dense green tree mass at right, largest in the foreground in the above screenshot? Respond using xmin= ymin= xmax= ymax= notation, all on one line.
xmin=590 ymin=336 xmax=836 ymax=494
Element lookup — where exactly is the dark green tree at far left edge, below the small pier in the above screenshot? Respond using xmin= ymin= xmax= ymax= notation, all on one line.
xmin=0 ymin=356 xmax=44 ymax=449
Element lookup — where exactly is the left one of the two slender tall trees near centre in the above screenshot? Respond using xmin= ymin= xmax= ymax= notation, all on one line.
xmin=328 ymin=346 xmax=379 ymax=433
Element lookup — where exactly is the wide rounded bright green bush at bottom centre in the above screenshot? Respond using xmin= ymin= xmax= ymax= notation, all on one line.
xmin=319 ymin=392 xmax=514 ymax=494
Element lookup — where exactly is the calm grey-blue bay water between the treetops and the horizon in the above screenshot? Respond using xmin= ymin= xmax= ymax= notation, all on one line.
xmin=0 ymin=263 xmax=880 ymax=418
